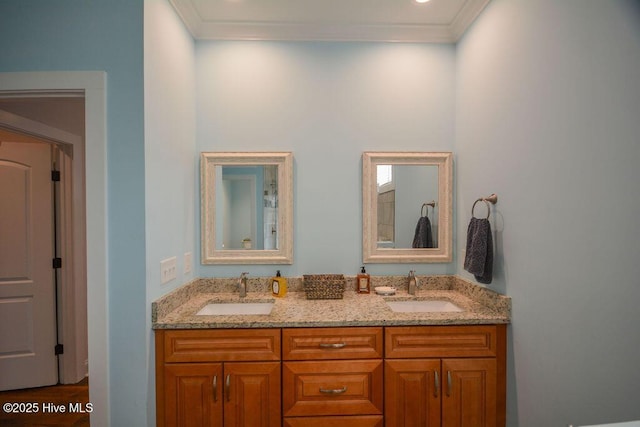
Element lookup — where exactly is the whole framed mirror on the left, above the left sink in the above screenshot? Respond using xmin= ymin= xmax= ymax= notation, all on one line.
xmin=200 ymin=152 xmax=293 ymax=264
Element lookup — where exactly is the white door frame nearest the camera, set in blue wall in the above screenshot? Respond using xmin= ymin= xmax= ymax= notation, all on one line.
xmin=0 ymin=71 xmax=110 ymax=427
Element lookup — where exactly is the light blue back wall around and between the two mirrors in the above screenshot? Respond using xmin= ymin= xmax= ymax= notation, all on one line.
xmin=196 ymin=41 xmax=455 ymax=277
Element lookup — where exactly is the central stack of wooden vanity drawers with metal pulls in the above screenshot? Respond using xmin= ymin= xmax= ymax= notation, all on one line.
xmin=282 ymin=327 xmax=384 ymax=427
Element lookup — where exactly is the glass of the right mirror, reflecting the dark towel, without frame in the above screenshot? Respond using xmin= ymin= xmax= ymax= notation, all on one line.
xmin=376 ymin=164 xmax=439 ymax=248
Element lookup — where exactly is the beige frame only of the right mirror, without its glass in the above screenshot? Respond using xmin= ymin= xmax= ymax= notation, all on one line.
xmin=362 ymin=152 xmax=453 ymax=263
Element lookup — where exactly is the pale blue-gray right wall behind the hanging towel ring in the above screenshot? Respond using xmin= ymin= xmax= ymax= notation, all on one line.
xmin=455 ymin=0 xmax=640 ymax=427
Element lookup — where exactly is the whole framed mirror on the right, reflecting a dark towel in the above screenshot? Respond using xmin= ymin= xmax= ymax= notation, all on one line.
xmin=362 ymin=152 xmax=453 ymax=263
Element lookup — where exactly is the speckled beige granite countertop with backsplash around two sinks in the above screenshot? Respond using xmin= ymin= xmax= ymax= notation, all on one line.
xmin=152 ymin=276 xmax=511 ymax=329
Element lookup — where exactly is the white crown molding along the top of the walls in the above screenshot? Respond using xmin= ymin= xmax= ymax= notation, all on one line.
xmin=169 ymin=0 xmax=490 ymax=43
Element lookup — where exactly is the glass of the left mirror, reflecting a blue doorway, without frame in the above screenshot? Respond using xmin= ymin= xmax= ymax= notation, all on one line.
xmin=216 ymin=165 xmax=278 ymax=250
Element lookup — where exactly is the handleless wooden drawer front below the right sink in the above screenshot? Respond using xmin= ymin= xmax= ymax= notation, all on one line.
xmin=385 ymin=325 xmax=504 ymax=359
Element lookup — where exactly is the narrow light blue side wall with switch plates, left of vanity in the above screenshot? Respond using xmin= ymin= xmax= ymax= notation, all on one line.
xmin=144 ymin=0 xmax=200 ymax=426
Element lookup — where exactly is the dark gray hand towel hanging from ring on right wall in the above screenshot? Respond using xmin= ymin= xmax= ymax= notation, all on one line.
xmin=464 ymin=218 xmax=493 ymax=284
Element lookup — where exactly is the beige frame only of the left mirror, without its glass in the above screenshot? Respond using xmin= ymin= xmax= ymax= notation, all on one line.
xmin=200 ymin=152 xmax=293 ymax=264
